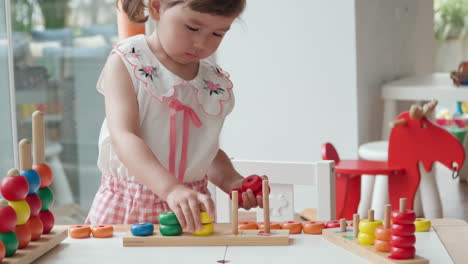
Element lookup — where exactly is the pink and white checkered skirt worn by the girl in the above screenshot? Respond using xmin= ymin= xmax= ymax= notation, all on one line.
xmin=86 ymin=175 xmax=210 ymax=225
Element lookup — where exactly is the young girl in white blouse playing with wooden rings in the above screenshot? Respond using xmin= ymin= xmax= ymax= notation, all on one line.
xmin=86 ymin=0 xmax=262 ymax=232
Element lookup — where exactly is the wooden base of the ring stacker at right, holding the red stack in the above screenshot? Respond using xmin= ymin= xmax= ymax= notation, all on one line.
xmin=322 ymin=228 xmax=429 ymax=264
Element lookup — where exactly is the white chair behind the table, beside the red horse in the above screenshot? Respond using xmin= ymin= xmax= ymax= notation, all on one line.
xmin=215 ymin=160 xmax=336 ymax=223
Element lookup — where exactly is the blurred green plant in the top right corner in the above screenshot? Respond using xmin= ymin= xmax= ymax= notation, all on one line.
xmin=434 ymin=0 xmax=468 ymax=40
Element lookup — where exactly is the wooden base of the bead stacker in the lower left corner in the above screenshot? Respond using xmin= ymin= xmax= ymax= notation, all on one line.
xmin=2 ymin=226 xmax=68 ymax=264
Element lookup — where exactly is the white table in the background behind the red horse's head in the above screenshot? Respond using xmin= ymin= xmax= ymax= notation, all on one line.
xmin=382 ymin=73 xmax=468 ymax=181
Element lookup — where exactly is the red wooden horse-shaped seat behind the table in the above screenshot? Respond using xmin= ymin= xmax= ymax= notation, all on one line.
xmin=321 ymin=101 xmax=465 ymax=220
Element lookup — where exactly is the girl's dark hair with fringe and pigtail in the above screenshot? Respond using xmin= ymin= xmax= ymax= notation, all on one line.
xmin=117 ymin=0 xmax=246 ymax=23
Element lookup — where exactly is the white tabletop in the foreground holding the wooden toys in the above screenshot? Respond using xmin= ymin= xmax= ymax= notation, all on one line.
xmin=34 ymin=232 xmax=452 ymax=264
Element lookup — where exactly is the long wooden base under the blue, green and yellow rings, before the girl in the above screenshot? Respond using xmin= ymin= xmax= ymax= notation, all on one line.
xmin=123 ymin=224 xmax=289 ymax=247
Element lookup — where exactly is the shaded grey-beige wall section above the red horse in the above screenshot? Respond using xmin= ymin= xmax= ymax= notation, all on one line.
xmin=356 ymin=0 xmax=435 ymax=143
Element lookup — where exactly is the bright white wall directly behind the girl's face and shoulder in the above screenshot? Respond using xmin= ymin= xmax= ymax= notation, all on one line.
xmin=218 ymin=0 xmax=358 ymax=161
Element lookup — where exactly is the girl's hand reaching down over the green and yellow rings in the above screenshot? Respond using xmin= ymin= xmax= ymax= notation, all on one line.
xmin=166 ymin=184 xmax=215 ymax=232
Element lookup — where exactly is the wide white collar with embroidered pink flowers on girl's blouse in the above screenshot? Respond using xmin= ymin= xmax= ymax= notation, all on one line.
xmin=114 ymin=35 xmax=233 ymax=116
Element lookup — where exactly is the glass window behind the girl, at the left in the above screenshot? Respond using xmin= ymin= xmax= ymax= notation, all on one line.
xmin=0 ymin=0 xmax=118 ymax=224
